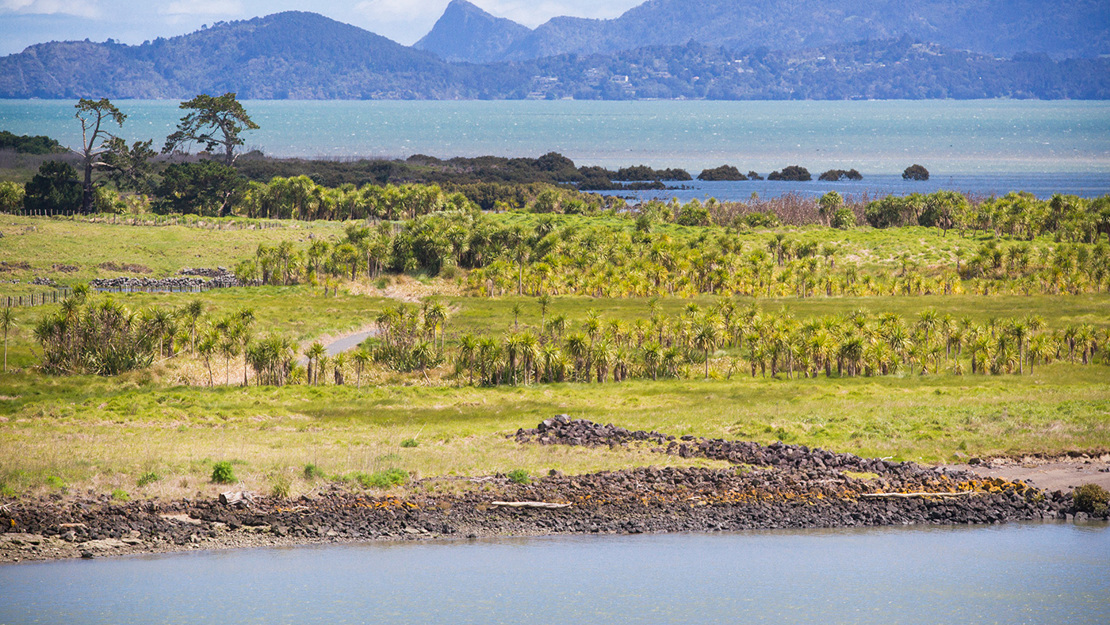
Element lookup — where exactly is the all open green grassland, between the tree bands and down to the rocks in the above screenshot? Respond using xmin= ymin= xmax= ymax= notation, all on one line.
xmin=0 ymin=215 xmax=1110 ymax=496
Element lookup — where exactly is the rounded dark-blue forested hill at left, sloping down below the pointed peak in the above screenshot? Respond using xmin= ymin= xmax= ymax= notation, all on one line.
xmin=0 ymin=11 xmax=474 ymax=99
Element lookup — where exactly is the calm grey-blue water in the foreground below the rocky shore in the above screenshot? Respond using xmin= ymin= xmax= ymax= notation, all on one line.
xmin=0 ymin=524 xmax=1110 ymax=625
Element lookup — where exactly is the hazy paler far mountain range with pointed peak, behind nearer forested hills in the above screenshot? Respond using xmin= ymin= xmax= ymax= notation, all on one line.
xmin=422 ymin=0 xmax=1110 ymax=62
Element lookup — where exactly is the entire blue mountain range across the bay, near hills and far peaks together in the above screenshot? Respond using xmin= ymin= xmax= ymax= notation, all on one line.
xmin=0 ymin=0 xmax=1110 ymax=99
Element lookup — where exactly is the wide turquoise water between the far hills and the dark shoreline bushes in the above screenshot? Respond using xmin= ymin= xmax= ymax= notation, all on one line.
xmin=0 ymin=100 xmax=1110 ymax=178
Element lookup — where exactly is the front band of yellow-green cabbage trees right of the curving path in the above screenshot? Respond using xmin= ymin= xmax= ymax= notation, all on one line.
xmin=437 ymin=298 xmax=1110 ymax=385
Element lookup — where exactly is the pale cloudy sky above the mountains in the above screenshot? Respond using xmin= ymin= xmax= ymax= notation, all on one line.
xmin=0 ymin=0 xmax=644 ymax=54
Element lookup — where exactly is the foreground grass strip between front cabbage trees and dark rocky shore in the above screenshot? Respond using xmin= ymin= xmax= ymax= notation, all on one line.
xmin=0 ymin=363 xmax=1110 ymax=493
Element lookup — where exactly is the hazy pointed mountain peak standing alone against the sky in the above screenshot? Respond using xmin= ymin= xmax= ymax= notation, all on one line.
xmin=413 ymin=0 xmax=532 ymax=63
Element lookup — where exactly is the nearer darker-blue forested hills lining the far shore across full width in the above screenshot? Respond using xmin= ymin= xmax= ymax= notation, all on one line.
xmin=0 ymin=8 xmax=1110 ymax=100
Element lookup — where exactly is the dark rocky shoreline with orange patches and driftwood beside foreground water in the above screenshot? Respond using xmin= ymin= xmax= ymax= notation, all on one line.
xmin=0 ymin=415 xmax=1106 ymax=562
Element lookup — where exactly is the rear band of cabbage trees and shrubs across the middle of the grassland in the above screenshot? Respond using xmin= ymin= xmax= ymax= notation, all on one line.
xmin=218 ymin=192 xmax=1110 ymax=298
